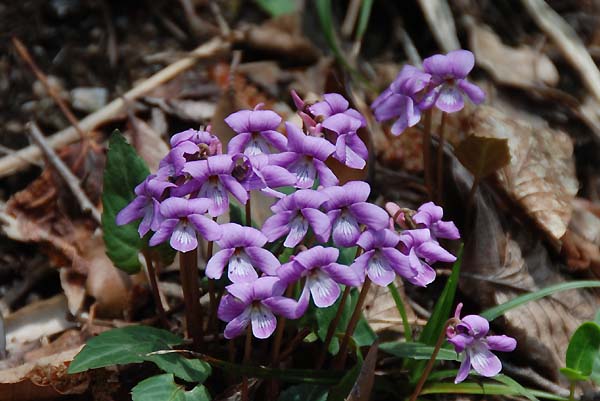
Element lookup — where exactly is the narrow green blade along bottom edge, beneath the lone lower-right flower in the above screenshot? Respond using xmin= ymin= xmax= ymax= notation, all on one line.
xmin=421 ymin=382 xmax=569 ymax=401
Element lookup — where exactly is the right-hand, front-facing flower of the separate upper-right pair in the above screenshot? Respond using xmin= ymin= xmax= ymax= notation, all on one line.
xmin=423 ymin=50 xmax=485 ymax=113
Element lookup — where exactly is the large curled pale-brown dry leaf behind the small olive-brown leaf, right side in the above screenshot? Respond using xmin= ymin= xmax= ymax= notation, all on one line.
xmin=469 ymin=106 xmax=578 ymax=243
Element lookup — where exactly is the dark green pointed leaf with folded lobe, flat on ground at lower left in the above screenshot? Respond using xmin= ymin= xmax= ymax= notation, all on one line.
xmin=69 ymin=326 xmax=211 ymax=382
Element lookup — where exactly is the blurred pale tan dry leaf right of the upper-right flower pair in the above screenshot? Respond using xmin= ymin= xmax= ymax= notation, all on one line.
xmin=468 ymin=22 xmax=559 ymax=88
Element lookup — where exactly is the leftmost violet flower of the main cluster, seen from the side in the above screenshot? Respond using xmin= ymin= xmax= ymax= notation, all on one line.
xmin=115 ymin=175 xmax=161 ymax=237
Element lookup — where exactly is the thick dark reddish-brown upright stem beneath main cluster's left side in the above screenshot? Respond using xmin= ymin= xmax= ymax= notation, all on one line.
xmin=179 ymin=249 xmax=203 ymax=349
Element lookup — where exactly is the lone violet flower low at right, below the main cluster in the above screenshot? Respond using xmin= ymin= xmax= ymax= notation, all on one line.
xmin=446 ymin=303 xmax=517 ymax=383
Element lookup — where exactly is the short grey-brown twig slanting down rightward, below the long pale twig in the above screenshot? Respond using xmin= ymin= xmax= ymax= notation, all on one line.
xmin=29 ymin=122 xmax=101 ymax=224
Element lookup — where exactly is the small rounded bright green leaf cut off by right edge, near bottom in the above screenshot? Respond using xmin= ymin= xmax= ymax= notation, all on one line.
xmin=567 ymin=322 xmax=600 ymax=377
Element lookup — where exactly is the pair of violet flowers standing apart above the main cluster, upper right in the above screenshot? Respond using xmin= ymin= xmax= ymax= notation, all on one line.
xmin=371 ymin=50 xmax=485 ymax=135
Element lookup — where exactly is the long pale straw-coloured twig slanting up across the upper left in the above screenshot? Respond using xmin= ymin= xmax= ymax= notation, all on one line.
xmin=0 ymin=38 xmax=229 ymax=177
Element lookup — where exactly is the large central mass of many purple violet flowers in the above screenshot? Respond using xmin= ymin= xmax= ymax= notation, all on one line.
xmin=117 ymin=93 xmax=459 ymax=338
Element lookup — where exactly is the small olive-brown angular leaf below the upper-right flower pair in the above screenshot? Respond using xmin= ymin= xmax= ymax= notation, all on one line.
xmin=454 ymin=135 xmax=510 ymax=180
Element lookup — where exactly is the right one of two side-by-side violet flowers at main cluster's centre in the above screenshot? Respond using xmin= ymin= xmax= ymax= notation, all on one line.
xmin=320 ymin=181 xmax=388 ymax=247
